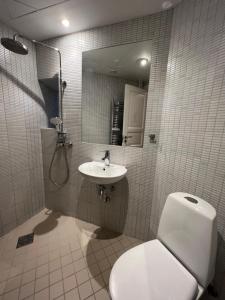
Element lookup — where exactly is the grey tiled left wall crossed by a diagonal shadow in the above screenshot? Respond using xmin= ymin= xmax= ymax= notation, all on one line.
xmin=0 ymin=23 xmax=46 ymax=235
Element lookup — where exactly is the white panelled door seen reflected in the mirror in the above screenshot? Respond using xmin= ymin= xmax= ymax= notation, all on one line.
xmin=123 ymin=84 xmax=147 ymax=147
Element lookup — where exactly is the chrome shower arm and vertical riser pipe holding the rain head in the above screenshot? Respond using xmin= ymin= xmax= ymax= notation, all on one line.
xmin=13 ymin=33 xmax=63 ymax=132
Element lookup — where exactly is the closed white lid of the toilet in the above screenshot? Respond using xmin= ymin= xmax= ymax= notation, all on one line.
xmin=109 ymin=240 xmax=198 ymax=300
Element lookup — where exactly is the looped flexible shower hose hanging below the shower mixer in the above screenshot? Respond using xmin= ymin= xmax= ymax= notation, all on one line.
xmin=49 ymin=143 xmax=70 ymax=187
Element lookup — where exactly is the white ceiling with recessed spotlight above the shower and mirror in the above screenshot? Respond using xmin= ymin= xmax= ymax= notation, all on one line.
xmin=0 ymin=0 xmax=180 ymax=40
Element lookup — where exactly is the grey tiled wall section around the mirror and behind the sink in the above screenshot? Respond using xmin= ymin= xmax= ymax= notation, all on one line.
xmin=42 ymin=11 xmax=172 ymax=239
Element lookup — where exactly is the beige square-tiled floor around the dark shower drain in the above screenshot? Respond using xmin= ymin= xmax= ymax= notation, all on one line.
xmin=0 ymin=210 xmax=140 ymax=300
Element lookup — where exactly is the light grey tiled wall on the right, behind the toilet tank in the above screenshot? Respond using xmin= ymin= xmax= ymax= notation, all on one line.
xmin=151 ymin=0 xmax=225 ymax=299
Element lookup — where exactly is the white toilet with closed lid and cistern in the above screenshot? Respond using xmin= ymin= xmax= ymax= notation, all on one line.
xmin=109 ymin=193 xmax=217 ymax=300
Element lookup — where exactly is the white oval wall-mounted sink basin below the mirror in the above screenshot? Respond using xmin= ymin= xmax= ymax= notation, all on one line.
xmin=78 ymin=161 xmax=127 ymax=184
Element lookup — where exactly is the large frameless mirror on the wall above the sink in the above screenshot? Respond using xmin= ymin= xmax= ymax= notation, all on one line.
xmin=82 ymin=41 xmax=151 ymax=147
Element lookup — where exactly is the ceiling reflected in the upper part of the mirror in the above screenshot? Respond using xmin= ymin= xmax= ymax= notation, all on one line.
xmin=82 ymin=41 xmax=152 ymax=81
